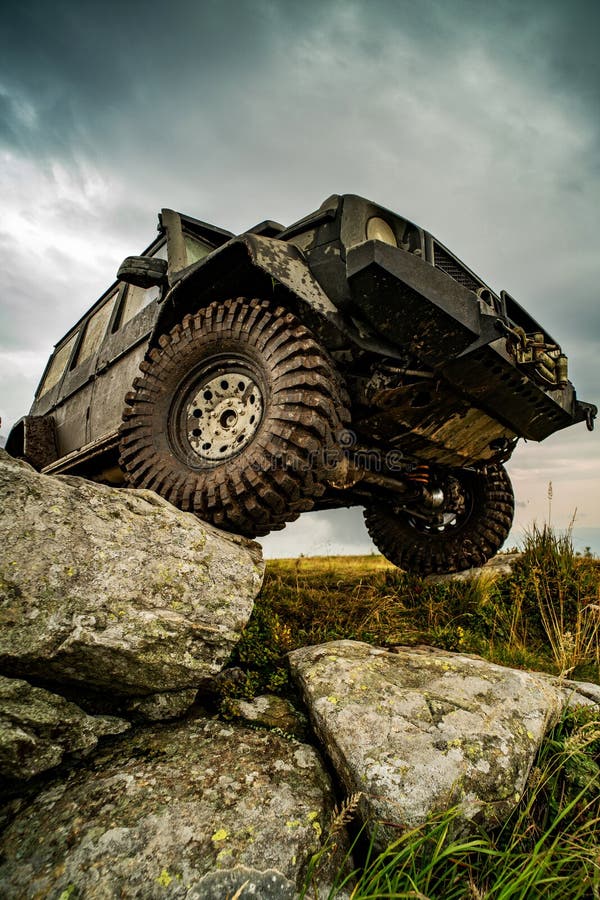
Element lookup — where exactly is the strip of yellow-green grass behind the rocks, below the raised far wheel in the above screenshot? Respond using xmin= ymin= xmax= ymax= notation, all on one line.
xmin=227 ymin=528 xmax=600 ymax=694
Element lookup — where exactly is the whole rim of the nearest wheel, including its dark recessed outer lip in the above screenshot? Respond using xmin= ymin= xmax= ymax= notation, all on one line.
xmin=171 ymin=363 xmax=264 ymax=468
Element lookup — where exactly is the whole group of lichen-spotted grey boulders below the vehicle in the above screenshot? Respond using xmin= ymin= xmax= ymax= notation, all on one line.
xmin=0 ymin=451 xmax=600 ymax=900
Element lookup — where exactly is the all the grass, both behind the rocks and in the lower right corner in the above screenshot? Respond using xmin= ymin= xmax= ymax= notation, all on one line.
xmin=221 ymin=528 xmax=600 ymax=900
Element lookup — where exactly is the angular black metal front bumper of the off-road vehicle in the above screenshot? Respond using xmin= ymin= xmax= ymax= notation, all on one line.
xmin=346 ymin=241 xmax=597 ymax=441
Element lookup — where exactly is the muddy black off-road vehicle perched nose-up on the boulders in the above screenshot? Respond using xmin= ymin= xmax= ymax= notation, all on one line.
xmin=7 ymin=195 xmax=596 ymax=573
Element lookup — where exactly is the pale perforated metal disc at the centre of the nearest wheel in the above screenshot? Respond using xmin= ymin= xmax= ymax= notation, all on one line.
xmin=185 ymin=371 xmax=263 ymax=462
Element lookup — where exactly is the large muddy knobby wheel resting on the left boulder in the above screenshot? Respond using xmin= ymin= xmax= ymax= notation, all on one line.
xmin=120 ymin=298 xmax=349 ymax=537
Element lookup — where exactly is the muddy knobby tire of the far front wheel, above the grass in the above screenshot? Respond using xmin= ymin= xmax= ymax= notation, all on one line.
xmin=364 ymin=465 xmax=514 ymax=575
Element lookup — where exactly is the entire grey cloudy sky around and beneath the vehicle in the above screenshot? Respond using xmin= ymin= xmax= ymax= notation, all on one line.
xmin=0 ymin=0 xmax=600 ymax=555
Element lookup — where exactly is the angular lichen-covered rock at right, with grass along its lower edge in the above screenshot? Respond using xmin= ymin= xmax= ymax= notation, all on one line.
xmin=290 ymin=641 xmax=565 ymax=840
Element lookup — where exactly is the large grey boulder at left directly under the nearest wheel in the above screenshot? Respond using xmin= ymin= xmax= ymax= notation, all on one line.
xmin=0 ymin=451 xmax=263 ymax=695
